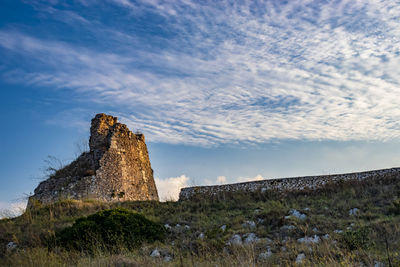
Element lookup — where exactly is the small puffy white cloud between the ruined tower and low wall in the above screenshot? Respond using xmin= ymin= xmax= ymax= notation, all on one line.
xmin=155 ymin=175 xmax=190 ymax=201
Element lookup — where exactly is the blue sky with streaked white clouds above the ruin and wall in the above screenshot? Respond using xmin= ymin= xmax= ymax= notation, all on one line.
xmin=0 ymin=0 xmax=400 ymax=214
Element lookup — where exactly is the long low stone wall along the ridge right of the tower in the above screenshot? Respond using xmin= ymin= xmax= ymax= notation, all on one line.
xmin=179 ymin=168 xmax=400 ymax=200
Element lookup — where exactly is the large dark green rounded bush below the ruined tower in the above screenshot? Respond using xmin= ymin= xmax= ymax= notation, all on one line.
xmin=56 ymin=208 xmax=166 ymax=252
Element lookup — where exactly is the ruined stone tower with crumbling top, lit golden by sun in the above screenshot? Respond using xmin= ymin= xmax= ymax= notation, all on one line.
xmin=28 ymin=113 xmax=158 ymax=207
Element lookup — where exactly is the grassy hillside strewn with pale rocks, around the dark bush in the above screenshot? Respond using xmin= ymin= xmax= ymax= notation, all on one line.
xmin=0 ymin=174 xmax=400 ymax=266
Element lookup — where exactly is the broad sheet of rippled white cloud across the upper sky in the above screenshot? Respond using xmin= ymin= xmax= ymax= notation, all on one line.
xmin=0 ymin=0 xmax=400 ymax=146
